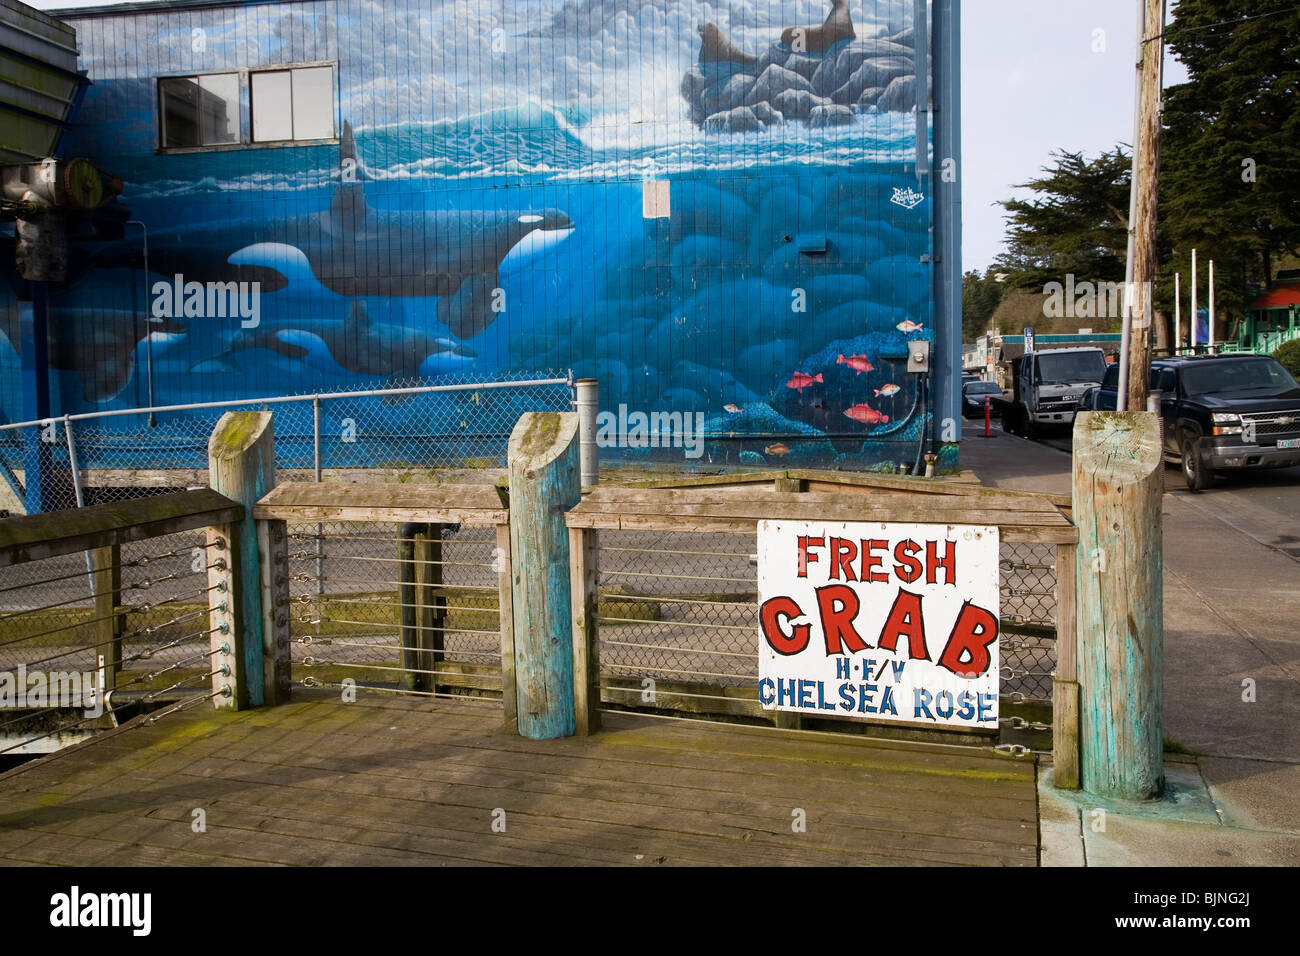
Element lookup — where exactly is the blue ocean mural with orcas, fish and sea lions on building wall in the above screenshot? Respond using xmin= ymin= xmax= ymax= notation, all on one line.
xmin=0 ymin=0 xmax=946 ymax=467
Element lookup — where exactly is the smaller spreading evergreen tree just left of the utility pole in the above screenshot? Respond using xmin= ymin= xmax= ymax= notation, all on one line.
xmin=997 ymin=146 xmax=1132 ymax=287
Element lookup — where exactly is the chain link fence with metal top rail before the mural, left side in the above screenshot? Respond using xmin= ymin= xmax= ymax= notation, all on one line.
xmin=0 ymin=372 xmax=573 ymax=511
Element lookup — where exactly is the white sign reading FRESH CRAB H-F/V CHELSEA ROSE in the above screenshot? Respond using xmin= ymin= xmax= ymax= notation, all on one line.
xmin=758 ymin=520 xmax=1001 ymax=730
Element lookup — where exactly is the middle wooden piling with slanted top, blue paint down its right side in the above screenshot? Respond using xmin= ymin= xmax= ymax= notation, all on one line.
xmin=508 ymin=412 xmax=582 ymax=739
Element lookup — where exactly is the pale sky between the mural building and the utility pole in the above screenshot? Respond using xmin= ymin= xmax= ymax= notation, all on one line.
xmin=29 ymin=0 xmax=1186 ymax=272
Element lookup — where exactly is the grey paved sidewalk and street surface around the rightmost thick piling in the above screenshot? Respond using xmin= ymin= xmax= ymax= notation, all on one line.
xmin=961 ymin=424 xmax=1300 ymax=866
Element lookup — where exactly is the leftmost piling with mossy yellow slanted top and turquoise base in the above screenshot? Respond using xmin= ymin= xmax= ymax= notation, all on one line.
xmin=208 ymin=411 xmax=277 ymax=706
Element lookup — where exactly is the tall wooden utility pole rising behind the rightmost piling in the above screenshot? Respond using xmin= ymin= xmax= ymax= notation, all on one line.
xmin=1122 ymin=0 xmax=1165 ymax=411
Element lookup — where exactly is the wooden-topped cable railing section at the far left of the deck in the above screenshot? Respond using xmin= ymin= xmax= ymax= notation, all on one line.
xmin=0 ymin=490 xmax=243 ymax=754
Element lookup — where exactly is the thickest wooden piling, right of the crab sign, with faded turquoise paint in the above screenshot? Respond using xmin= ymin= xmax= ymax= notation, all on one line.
xmin=1074 ymin=411 xmax=1165 ymax=800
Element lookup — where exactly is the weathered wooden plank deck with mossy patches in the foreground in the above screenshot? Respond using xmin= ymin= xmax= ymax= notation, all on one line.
xmin=0 ymin=688 xmax=1037 ymax=866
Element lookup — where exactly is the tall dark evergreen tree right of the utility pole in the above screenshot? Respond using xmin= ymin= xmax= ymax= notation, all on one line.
xmin=1160 ymin=0 xmax=1300 ymax=321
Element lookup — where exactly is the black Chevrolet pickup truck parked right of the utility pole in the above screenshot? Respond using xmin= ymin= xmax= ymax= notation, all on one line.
xmin=1079 ymin=355 xmax=1300 ymax=492
